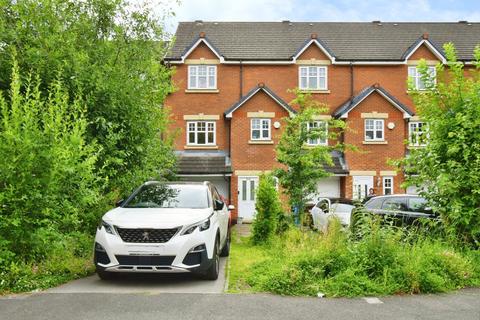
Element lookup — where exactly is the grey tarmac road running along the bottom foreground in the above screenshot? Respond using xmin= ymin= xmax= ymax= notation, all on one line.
xmin=0 ymin=289 xmax=480 ymax=320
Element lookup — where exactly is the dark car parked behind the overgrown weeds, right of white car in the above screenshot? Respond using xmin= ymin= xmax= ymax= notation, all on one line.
xmin=358 ymin=194 xmax=437 ymax=224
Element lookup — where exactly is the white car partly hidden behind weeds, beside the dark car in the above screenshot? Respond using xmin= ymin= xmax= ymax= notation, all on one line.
xmin=310 ymin=198 xmax=355 ymax=232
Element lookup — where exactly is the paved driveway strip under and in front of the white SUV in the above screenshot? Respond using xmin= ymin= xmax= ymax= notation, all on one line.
xmin=47 ymin=258 xmax=227 ymax=296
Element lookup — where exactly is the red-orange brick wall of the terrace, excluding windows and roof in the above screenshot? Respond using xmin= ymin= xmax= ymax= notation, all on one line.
xmin=166 ymin=44 xmax=442 ymax=205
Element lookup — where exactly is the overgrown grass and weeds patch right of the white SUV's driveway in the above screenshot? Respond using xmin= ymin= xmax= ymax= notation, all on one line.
xmin=229 ymin=223 xmax=480 ymax=297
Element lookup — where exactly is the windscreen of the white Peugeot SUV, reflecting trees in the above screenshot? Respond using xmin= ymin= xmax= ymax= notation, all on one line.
xmin=123 ymin=184 xmax=208 ymax=209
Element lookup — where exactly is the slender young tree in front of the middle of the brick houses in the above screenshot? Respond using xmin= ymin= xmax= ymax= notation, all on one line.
xmin=275 ymin=90 xmax=345 ymax=220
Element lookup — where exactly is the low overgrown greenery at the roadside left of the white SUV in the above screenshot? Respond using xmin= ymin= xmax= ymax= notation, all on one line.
xmin=0 ymin=233 xmax=94 ymax=295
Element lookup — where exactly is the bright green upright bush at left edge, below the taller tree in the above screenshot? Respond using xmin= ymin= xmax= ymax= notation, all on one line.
xmin=0 ymin=64 xmax=101 ymax=270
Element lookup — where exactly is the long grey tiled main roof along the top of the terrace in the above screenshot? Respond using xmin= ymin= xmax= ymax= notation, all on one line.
xmin=167 ymin=22 xmax=480 ymax=61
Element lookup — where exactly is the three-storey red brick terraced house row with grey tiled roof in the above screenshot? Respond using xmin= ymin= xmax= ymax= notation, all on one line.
xmin=165 ymin=21 xmax=480 ymax=219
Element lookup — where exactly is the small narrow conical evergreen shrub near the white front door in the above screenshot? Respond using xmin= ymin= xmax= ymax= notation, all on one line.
xmin=252 ymin=175 xmax=282 ymax=244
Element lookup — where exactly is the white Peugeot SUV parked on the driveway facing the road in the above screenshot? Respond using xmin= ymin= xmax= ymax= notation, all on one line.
xmin=94 ymin=181 xmax=233 ymax=280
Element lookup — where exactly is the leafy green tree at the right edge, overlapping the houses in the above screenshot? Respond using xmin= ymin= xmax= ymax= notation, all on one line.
xmin=401 ymin=44 xmax=480 ymax=246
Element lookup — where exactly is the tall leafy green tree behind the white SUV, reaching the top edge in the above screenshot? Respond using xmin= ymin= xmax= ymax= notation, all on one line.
xmin=0 ymin=0 xmax=174 ymax=193
